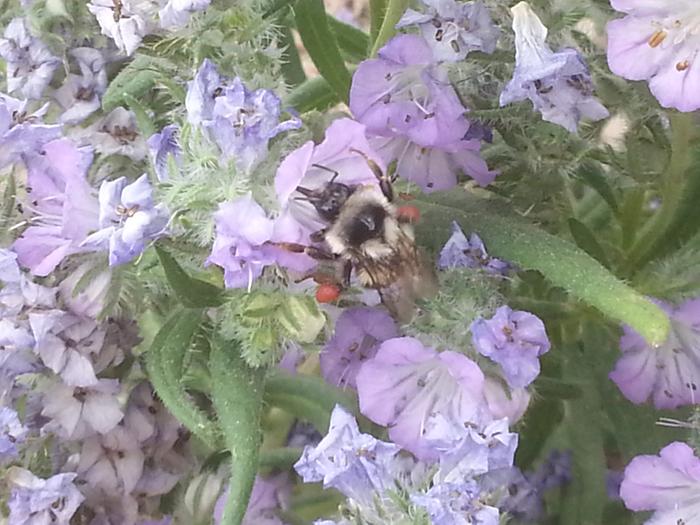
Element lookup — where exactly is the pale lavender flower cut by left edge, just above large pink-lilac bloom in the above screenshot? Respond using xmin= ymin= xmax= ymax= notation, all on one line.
xmin=0 ymin=93 xmax=61 ymax=169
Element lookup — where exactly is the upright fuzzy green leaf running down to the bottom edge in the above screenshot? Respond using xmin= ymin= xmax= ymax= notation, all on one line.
xmin=209 ymin=341 xmax=265 ymax=525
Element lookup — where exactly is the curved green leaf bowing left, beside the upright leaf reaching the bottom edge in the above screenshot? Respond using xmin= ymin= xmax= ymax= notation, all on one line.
xmin=146 ymin=309 xmax=219 ymax=448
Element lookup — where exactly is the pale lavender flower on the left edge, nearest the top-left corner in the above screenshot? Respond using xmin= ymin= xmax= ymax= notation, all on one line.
xmin=0 ymin=18 xmax=60 ymax=99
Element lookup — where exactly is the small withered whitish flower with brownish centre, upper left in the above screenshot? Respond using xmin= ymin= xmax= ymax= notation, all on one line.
xmin=80 ymin=107 xmax=148 ymax=162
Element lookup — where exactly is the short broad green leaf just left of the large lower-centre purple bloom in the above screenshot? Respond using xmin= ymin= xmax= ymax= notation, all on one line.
xmin=265 ymin=372 xmax=359 ymax=432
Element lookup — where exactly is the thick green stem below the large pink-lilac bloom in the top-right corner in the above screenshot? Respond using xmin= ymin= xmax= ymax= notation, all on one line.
xmin=627 ymin=113 xmax=694 ymax=272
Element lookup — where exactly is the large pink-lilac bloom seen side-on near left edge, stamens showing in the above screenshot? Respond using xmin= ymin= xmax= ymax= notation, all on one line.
xmin=12 ymin=139 xmax=97 ymax=277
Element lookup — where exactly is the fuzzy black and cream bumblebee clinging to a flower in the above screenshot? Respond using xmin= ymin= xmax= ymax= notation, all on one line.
xmin=274 ymin=150 xmax=437 ymax=322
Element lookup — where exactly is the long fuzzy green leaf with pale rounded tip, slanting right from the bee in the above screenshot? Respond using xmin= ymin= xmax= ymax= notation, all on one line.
xmin=415 ymin=189 xmax=670 ymax=345
